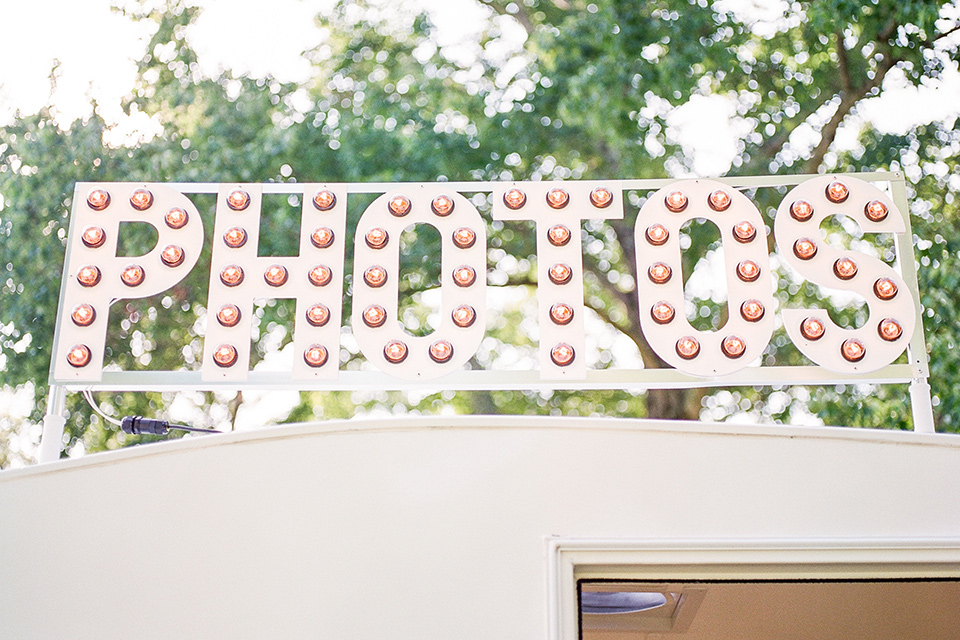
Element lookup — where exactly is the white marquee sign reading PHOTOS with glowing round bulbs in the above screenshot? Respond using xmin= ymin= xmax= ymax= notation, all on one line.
xmin=51 ymin=174 xmax=927 ymax=398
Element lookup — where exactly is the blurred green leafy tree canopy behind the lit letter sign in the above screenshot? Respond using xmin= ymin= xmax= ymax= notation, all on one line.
xmin=0 ymin=0 xmax=960 ymax=466
